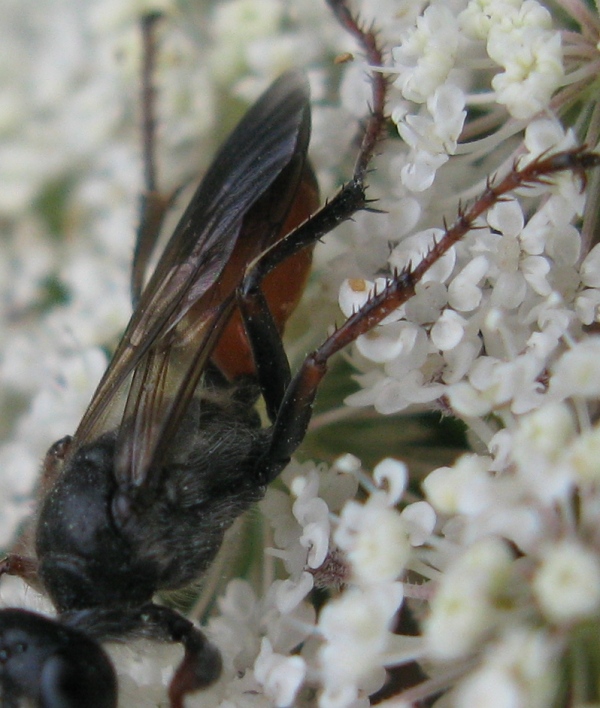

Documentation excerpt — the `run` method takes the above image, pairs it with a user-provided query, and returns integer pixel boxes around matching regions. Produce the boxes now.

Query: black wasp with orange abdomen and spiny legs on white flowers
[0,0,385,708]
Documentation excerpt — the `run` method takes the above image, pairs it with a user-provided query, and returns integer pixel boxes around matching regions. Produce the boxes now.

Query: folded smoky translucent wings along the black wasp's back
[73,72,310,487]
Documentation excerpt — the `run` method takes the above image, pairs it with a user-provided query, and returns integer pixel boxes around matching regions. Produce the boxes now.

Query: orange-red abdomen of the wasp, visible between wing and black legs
[212,168,319,380]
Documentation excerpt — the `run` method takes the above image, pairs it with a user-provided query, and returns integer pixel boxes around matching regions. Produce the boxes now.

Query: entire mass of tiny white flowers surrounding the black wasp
[0,0,600,708]
